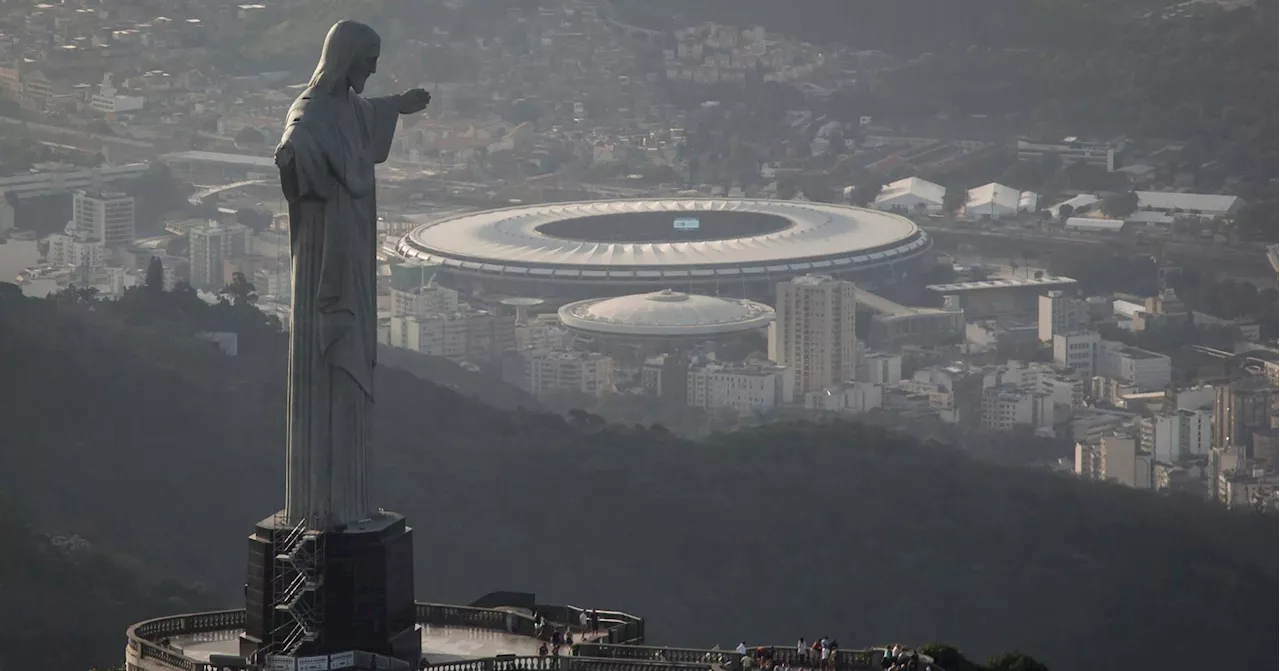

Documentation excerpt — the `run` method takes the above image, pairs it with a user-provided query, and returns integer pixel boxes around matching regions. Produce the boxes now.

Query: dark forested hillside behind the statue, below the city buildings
[0,288,1280,671]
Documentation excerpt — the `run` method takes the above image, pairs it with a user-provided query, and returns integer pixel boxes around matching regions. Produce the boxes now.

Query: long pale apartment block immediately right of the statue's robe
[388,310,516,364]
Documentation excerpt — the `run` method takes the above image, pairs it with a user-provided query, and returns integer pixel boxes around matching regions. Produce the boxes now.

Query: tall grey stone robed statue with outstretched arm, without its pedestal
[275,20,431,530]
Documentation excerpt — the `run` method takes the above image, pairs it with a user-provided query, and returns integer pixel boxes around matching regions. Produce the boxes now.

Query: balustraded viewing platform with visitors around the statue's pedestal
[125,593,884,671]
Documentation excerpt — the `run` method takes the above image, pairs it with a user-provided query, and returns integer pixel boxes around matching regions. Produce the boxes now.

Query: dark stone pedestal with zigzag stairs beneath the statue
[241,512,422,668]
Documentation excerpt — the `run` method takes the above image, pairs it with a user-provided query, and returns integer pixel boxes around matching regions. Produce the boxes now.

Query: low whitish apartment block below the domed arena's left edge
[503,350,613,396]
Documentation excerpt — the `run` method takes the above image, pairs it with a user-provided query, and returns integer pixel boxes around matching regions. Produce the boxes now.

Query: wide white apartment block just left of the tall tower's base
[686,361,795,414]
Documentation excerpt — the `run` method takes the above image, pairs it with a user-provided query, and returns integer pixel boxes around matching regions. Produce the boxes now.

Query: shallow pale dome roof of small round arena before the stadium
[559,289,773,337]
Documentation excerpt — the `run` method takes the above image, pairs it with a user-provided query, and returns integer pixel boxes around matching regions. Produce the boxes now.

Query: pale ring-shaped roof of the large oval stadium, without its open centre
[397,198,929,280]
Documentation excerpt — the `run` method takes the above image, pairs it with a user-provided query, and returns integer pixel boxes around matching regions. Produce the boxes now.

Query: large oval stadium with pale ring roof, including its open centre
[398,198,933,300]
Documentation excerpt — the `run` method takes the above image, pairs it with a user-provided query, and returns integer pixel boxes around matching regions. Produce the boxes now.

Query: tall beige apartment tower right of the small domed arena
[769,275,858,400]
